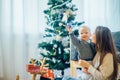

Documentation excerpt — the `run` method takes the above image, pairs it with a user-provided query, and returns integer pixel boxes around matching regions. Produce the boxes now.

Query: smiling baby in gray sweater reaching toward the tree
[66,26,95,61]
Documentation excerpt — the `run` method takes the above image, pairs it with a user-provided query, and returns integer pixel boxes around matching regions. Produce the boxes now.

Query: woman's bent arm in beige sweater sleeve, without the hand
[88,53,114,80]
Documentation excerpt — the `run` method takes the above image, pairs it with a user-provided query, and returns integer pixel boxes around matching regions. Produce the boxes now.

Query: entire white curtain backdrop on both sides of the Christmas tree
[0,0,120,80]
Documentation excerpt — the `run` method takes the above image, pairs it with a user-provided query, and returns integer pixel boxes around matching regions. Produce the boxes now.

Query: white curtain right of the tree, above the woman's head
[73,0,120,32]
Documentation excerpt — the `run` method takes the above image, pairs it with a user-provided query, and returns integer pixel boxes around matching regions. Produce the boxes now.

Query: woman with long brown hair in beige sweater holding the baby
[79,26,118,80]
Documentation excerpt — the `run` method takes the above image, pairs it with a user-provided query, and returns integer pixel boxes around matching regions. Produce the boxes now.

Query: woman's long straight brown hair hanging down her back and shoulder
[95,26,118,80]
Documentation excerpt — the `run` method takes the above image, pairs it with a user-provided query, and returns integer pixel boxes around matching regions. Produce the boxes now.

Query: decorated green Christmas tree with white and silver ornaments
[38,0,84,75]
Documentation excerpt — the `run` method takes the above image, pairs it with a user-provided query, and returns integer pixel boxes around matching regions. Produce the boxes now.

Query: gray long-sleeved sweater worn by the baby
[70,33,95,61]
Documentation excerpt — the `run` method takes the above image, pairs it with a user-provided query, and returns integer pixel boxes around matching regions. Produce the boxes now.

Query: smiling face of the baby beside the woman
[79,28,91,41]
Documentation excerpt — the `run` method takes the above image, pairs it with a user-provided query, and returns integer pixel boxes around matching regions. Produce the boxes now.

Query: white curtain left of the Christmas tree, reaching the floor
[0,0,47,80]
